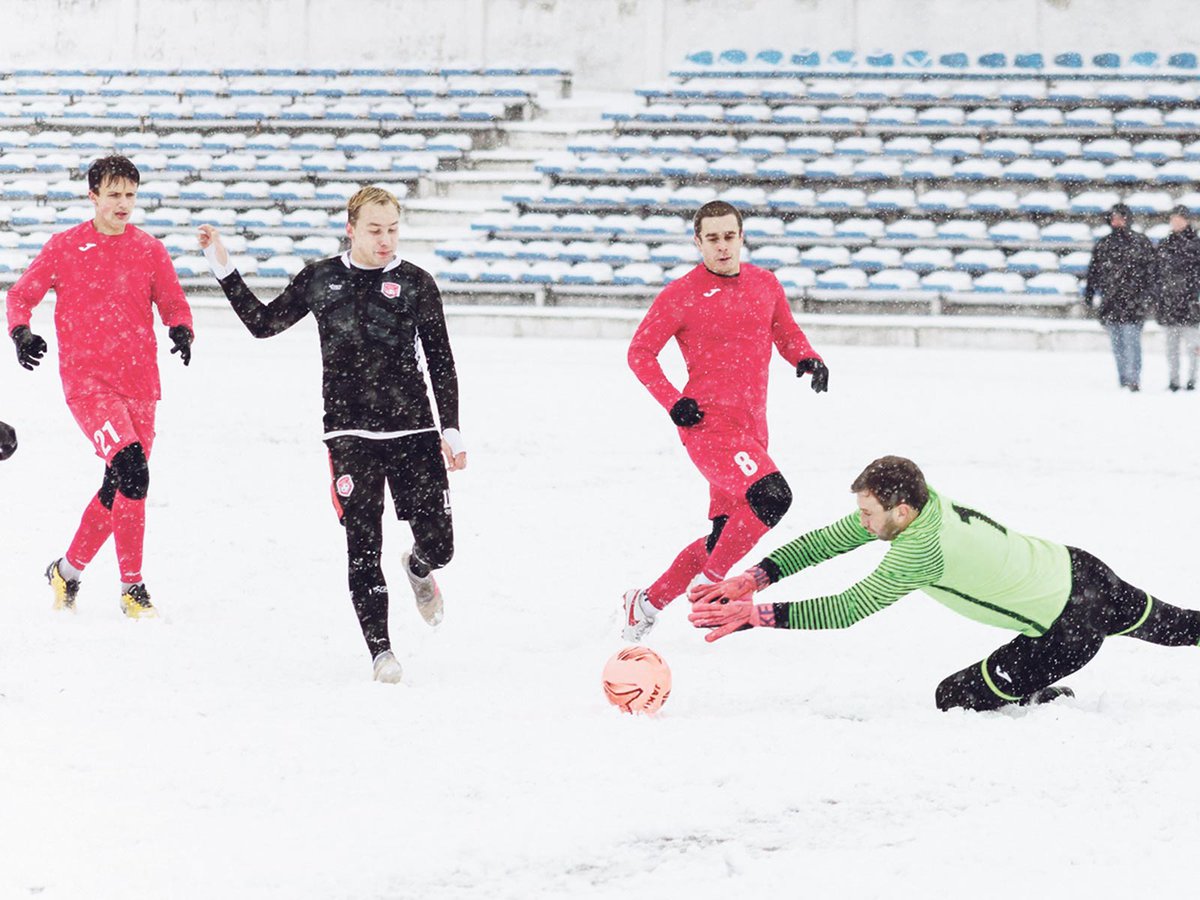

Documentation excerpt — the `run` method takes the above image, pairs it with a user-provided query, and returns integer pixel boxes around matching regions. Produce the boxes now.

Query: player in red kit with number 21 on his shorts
[7,156,193,618]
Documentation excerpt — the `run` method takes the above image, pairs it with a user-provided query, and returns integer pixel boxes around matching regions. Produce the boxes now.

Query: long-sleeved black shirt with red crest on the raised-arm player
[220,253,458,437]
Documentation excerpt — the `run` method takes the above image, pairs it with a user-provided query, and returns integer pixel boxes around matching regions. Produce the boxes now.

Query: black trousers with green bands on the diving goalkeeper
[935,547,1200,709]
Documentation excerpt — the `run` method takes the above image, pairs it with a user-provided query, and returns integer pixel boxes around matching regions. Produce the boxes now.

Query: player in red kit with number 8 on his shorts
[623,200,829,641]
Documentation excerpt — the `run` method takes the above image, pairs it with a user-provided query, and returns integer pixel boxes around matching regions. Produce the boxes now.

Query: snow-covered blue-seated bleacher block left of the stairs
[0,66,559,282]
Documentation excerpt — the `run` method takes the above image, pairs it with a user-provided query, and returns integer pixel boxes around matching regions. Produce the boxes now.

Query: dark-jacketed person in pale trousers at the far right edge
[1156,206,1200,391]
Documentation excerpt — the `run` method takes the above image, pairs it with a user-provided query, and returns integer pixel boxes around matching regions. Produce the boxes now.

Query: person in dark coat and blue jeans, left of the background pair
[1084,203,1158,391]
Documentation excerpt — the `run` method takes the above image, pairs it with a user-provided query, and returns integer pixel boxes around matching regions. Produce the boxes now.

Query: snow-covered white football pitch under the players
[0,311,1200,900]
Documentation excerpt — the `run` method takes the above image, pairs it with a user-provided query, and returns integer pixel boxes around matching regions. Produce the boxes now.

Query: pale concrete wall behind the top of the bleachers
[7,0,1200,90]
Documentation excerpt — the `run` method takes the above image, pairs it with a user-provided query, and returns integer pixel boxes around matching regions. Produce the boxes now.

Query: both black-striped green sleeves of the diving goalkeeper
[768,514,944,629]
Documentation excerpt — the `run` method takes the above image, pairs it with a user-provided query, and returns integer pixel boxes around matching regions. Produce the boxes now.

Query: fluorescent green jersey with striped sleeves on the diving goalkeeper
[763,488,1070,636]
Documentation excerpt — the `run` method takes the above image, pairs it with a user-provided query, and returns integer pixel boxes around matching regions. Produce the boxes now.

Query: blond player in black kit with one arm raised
[199,187,467,682]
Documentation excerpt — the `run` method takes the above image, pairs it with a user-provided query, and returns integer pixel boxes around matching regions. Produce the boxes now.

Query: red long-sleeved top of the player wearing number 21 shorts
[7,222,194,400]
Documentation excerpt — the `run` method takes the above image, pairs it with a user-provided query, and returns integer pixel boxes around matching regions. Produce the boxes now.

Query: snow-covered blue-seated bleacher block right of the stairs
[429,50,1200,312]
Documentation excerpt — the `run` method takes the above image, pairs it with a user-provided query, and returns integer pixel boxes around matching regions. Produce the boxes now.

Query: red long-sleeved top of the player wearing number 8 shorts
[629,263,820,443]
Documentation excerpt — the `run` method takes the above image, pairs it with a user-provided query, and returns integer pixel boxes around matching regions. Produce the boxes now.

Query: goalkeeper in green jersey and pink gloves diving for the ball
[689,456,1200,709]
